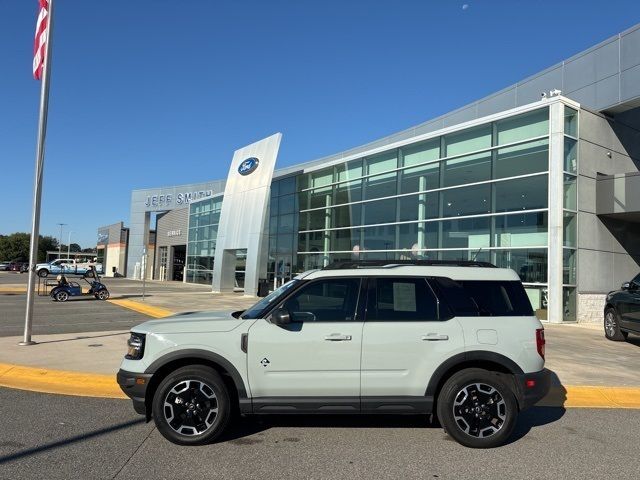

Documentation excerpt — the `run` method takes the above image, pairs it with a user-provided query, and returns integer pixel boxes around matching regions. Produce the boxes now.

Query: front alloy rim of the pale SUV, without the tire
[163,380,218,436]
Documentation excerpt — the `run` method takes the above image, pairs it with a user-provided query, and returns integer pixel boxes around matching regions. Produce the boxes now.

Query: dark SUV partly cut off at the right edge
[604,274,640,342]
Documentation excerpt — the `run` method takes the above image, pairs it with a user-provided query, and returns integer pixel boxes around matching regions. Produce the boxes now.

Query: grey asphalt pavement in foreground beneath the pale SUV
[0,388,640,480]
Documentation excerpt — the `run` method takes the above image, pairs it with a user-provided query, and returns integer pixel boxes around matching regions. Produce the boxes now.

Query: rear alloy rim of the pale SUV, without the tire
[453,383,507,438]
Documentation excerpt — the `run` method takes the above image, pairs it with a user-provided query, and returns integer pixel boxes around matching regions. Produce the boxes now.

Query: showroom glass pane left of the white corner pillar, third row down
[493,175,548,212]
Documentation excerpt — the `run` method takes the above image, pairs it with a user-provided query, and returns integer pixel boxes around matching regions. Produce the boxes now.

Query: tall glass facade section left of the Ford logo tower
[185,196,222,285]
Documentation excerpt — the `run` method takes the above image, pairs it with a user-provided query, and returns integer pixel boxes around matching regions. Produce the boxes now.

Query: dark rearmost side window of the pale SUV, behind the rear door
[430,278,533,317]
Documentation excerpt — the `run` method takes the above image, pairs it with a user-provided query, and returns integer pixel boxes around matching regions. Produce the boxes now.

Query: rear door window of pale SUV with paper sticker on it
[368,278,438,322]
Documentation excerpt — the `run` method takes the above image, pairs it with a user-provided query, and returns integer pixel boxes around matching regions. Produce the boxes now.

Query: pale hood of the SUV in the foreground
[131,311,244,334]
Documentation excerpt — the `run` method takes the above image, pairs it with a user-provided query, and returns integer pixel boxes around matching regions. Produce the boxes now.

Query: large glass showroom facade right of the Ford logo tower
[269,106,592,320]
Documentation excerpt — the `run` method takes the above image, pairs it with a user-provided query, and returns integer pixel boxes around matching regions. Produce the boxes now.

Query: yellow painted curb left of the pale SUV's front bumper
[0,363,127,398]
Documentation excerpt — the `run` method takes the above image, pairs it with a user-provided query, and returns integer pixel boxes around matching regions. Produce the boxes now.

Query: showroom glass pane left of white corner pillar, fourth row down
[493,212,548,247]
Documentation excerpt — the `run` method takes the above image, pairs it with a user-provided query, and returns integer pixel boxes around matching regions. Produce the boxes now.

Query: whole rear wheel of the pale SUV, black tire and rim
[436,368,518,448]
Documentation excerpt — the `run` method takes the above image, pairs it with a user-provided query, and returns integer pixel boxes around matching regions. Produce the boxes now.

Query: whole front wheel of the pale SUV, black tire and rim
[152,365,231,445]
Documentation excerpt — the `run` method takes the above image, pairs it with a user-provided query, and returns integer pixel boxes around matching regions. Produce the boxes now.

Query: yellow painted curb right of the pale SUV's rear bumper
[537,385,640,408]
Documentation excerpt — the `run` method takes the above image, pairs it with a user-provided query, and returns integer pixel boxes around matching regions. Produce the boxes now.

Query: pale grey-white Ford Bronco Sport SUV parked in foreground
[118,261,550,448]
